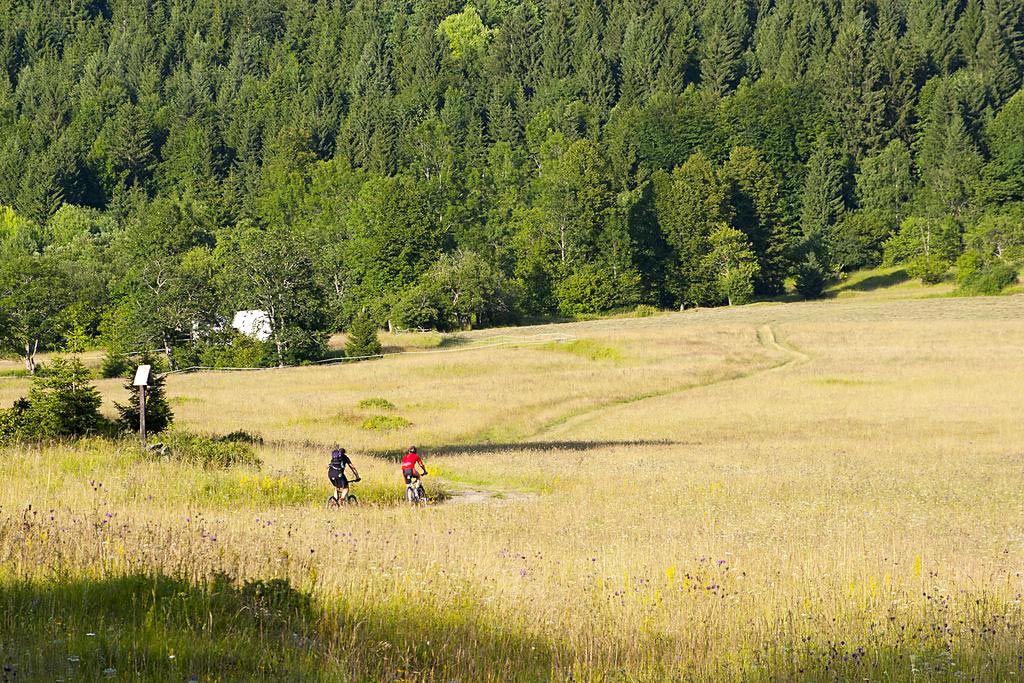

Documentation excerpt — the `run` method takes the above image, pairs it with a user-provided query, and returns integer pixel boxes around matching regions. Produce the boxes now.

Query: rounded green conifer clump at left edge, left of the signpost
[0,358,111,445]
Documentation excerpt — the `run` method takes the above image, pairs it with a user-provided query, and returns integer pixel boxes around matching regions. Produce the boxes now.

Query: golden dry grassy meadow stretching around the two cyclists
[0,292,1024,682]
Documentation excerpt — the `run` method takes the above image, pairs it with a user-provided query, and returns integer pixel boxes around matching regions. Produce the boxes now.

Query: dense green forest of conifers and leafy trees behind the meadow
[0,0,1024,365]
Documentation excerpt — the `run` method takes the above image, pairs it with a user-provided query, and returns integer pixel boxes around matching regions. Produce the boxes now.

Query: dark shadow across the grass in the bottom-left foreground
[0,574,554,681]
